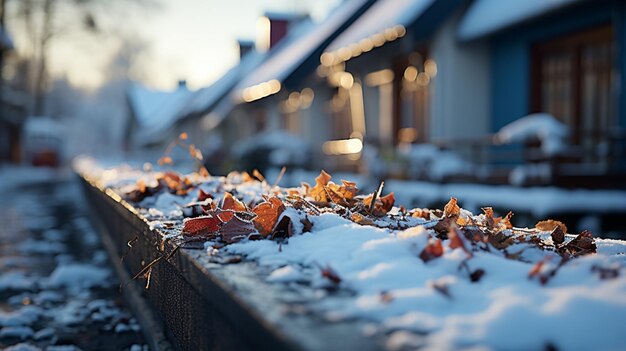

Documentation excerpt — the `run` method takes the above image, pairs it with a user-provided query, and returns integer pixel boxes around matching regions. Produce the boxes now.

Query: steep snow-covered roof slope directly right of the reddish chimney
[232,0,367,101]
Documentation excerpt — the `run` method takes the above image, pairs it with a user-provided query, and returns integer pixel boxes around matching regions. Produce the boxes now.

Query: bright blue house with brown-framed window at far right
[458,0,626,186]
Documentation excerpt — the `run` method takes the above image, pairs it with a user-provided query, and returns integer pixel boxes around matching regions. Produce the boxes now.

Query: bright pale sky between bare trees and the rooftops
[42,0,340,89]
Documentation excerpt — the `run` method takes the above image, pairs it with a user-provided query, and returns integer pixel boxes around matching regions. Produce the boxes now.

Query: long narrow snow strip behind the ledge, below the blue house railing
[385,179,626,218]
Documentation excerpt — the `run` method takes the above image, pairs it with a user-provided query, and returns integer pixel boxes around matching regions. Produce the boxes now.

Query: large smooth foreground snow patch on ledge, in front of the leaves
[226,215,626,349]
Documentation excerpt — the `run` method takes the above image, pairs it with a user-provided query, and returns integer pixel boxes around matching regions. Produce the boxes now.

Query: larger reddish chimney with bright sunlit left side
[257,12,308,52]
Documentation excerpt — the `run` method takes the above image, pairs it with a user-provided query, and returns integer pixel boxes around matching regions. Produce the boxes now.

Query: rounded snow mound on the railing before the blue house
[495,113,569,156]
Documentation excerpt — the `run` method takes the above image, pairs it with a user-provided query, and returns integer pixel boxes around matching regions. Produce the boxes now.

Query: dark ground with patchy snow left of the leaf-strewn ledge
[0,167,147,351]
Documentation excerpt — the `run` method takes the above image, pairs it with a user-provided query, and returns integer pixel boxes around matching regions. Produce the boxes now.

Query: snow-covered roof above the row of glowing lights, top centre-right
[327,0,434,52]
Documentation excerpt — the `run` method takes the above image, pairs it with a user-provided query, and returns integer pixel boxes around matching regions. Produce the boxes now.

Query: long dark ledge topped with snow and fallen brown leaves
[77,158,626,350]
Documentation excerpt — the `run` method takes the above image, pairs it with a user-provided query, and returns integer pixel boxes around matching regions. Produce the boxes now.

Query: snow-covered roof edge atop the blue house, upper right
[458,0,583,40]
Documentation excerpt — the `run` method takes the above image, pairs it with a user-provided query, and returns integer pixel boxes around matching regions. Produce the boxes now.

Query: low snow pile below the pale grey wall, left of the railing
[401,144,475,181]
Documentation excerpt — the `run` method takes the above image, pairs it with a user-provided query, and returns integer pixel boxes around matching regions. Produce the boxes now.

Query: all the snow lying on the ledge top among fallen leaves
[77,161,626,350]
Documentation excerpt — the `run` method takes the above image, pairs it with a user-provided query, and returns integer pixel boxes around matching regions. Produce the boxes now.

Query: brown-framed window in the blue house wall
[531,26,616,136]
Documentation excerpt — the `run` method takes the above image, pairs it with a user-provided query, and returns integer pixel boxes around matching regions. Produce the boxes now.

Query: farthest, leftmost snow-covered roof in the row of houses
[128,83,192,144]
